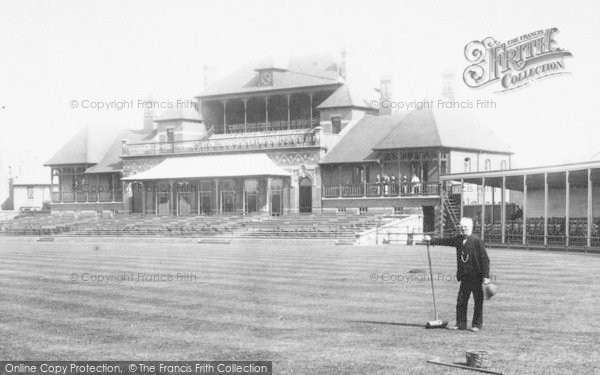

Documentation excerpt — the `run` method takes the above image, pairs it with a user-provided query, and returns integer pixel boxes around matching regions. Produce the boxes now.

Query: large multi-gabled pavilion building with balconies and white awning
[46,54,511,234]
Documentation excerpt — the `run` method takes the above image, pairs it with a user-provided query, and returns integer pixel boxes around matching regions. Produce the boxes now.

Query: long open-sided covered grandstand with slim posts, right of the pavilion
[441,161,600,250]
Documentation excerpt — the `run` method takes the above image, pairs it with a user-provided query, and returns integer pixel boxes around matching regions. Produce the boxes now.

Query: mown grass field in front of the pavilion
[0,238,600,374]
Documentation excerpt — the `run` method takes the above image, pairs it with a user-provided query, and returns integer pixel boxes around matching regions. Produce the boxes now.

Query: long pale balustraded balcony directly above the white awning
[123,131,320,156]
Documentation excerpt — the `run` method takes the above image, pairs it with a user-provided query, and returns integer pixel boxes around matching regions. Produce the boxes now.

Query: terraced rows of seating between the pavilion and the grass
[0,214,392,239]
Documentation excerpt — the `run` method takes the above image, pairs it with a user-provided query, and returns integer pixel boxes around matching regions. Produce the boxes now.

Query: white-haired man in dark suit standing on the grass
[425,217,490,332]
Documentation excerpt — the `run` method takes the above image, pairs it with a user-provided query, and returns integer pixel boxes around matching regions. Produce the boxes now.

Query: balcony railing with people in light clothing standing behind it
[323,182,440,198]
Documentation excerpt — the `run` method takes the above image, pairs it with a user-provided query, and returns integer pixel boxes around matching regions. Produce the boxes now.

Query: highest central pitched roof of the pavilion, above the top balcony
[199,54,341,97]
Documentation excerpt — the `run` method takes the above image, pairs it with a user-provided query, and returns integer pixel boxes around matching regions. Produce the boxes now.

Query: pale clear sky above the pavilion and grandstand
[0,0,600,191]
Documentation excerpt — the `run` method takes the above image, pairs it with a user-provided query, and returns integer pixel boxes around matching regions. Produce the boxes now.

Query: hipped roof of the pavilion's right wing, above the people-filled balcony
[373,109,511,153]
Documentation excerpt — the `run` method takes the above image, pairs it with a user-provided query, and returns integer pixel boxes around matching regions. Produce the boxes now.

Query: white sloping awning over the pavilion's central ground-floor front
[123,154,291,181]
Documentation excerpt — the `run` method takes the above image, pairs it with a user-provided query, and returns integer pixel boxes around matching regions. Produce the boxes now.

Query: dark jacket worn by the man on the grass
[431,235,490,282]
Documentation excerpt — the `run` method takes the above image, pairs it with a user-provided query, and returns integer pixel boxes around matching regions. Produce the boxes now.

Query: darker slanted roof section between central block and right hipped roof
[321,113,405,164]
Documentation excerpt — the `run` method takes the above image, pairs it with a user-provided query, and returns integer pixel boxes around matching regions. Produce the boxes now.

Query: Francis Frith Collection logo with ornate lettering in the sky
[463,27,572,92]
